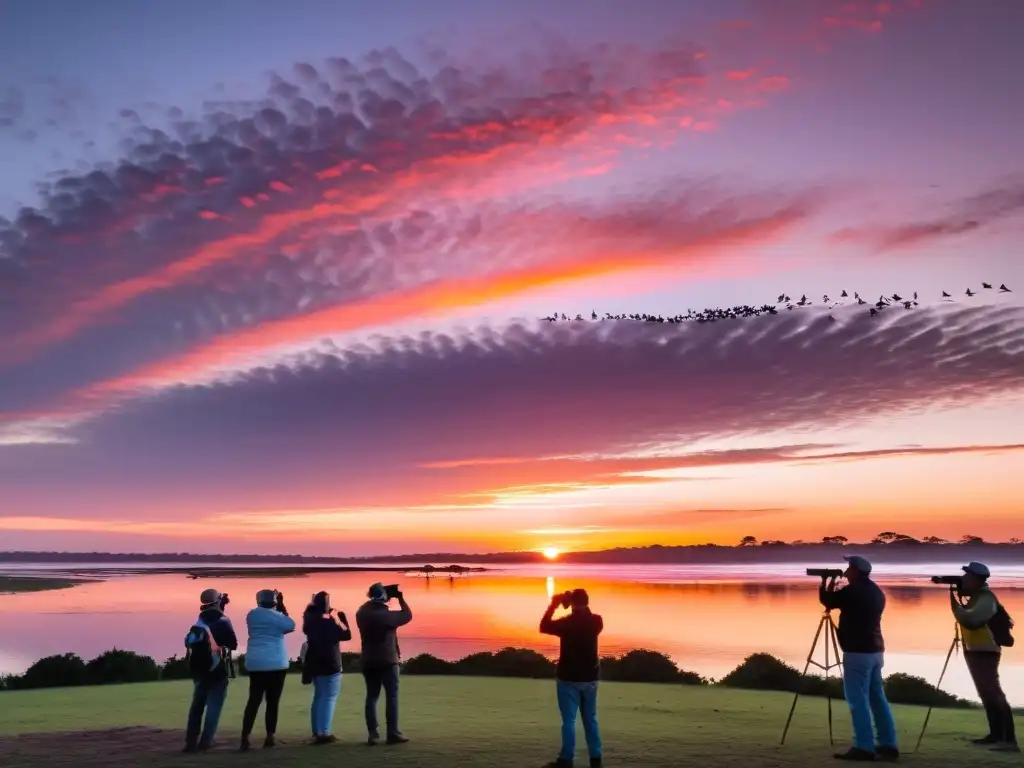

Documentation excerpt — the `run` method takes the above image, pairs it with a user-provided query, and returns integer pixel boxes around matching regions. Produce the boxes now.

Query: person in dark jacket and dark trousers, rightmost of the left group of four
[355,582,413,746]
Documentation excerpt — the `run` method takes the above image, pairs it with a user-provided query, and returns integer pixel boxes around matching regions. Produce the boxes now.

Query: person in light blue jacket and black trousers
[241,590,295,752]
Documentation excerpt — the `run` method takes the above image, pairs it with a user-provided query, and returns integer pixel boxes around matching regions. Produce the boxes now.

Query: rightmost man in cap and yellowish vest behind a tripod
[949,562,1020,752]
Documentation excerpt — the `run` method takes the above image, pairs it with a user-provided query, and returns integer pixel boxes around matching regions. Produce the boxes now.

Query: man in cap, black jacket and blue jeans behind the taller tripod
[818,555,899,762]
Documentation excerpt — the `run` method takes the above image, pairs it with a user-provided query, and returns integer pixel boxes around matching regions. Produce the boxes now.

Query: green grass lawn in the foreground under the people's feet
[0,675,1024,768]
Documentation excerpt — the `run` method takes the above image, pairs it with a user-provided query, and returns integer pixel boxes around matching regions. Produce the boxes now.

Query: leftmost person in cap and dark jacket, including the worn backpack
[184,589,239,752]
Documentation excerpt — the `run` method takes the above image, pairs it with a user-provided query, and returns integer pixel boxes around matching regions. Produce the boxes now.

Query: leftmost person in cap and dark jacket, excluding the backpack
[184,589,239,752]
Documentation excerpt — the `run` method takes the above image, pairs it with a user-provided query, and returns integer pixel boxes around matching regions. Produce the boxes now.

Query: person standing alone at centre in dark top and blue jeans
[541,589,604,768]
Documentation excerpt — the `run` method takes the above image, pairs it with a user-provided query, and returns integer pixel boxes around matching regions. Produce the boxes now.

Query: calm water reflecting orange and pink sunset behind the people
[0,563,1024,706]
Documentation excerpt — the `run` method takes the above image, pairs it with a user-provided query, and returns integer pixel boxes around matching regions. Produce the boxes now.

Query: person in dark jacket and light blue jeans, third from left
[302,592,352,744]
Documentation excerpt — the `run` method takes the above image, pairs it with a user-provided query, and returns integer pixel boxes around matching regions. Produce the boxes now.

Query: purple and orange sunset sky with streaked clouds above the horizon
[0,0,1024,555]
